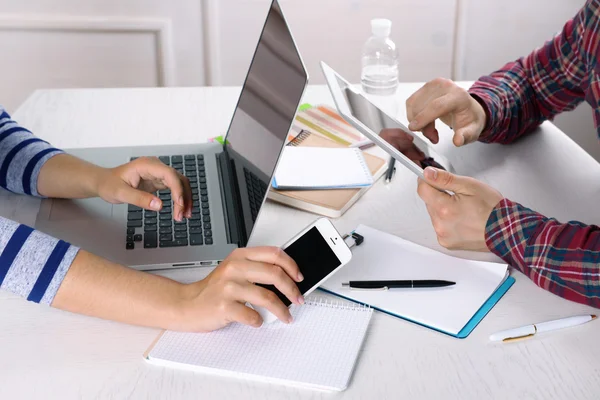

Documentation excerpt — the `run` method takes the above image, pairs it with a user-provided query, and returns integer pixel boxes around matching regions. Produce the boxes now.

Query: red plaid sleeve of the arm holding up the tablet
[485,199,600,308]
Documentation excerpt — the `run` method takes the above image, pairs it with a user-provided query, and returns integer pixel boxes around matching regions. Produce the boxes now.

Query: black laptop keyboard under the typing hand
[125,154,213,250]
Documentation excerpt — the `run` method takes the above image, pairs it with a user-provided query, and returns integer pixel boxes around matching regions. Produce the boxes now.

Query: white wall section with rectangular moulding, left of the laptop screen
[0,0,206,110]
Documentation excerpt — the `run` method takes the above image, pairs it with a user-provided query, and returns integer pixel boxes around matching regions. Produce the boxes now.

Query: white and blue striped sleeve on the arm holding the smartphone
[0,217,79,305]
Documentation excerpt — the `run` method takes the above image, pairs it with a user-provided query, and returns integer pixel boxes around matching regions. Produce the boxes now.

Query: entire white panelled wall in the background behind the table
[0,0,600,160]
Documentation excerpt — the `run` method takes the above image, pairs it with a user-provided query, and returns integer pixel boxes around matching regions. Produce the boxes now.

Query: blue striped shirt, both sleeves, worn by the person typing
[0,106,79,305]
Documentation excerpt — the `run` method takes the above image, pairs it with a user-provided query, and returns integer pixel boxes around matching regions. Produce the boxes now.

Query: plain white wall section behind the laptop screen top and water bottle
[208,0,456,85]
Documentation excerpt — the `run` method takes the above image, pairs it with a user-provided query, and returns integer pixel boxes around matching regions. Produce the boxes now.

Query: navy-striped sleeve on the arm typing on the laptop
[0,106,62,197]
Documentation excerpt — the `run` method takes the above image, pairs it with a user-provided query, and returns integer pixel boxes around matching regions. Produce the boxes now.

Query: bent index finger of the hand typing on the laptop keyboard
[136,158,185,221]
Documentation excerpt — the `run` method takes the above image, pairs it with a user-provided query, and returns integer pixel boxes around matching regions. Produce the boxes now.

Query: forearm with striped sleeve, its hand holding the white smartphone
[0,217,191,329]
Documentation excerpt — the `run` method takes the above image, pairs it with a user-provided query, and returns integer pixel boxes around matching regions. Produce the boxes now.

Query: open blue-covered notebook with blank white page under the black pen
[321,225,515,339]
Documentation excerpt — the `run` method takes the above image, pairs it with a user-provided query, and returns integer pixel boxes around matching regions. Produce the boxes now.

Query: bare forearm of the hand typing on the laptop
[37,154,106,199]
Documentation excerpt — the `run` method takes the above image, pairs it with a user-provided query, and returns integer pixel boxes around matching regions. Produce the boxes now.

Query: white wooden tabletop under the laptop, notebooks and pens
[0,84,600,399]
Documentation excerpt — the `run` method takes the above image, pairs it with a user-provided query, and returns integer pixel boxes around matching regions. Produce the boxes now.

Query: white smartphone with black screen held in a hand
[252,218,352,323]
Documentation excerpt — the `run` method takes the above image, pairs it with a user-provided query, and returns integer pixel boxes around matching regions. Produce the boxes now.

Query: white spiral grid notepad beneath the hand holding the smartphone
[146,298,372,390]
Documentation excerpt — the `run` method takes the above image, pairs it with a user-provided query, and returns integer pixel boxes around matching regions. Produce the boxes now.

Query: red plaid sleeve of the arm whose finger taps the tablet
[469,0,588,144]
